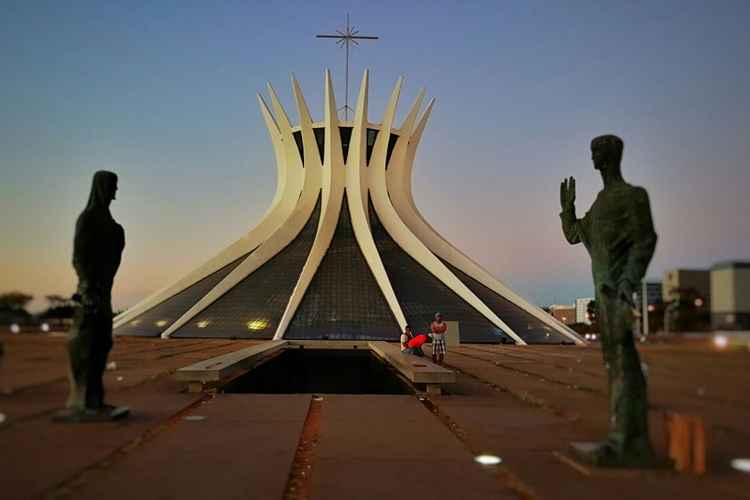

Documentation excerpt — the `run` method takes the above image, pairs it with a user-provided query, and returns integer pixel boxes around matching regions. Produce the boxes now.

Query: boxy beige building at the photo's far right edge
[711,261,750,330]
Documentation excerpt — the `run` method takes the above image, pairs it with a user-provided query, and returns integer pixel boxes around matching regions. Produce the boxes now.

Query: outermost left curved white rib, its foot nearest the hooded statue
[114,94,302,328]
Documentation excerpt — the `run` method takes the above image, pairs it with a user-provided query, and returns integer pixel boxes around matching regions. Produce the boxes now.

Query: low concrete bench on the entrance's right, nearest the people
[369,342,456,395]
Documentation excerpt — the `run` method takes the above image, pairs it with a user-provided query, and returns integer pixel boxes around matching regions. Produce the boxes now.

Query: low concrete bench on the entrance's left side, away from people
[175,340,288,392]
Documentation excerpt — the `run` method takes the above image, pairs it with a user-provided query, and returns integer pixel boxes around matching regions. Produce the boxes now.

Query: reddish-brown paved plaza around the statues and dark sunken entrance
[0,334,750,500]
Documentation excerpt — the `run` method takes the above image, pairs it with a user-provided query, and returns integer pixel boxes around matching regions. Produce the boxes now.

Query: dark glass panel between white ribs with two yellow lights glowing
[172,199,320,339]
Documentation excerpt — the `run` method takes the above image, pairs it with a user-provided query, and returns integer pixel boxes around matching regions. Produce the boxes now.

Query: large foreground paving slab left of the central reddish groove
[70,394,310,500]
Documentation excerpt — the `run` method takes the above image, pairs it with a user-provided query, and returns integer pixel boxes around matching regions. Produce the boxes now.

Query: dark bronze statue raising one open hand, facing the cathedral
[560,135,656,466]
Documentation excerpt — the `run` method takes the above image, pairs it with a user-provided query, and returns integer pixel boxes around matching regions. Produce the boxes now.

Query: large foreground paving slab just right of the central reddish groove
[312,395,515,500]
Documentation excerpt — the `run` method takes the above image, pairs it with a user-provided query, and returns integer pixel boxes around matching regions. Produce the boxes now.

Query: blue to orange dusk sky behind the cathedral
[0,0,750,308]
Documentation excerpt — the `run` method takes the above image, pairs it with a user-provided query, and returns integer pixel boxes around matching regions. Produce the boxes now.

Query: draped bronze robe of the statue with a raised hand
[560,181,656,456]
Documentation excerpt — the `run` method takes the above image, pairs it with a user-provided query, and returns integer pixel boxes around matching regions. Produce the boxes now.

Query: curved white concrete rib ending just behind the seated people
[346,70,406,330]
